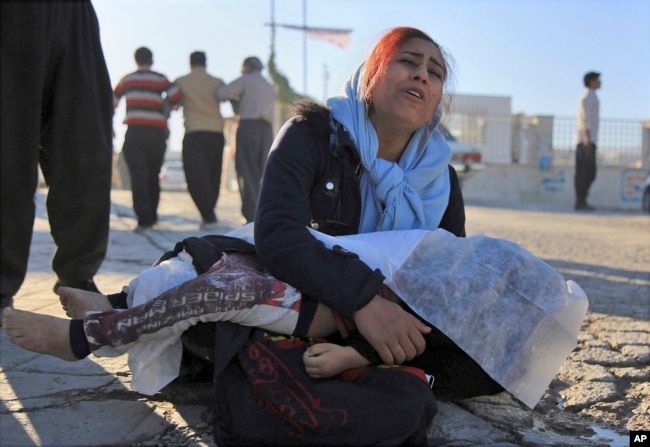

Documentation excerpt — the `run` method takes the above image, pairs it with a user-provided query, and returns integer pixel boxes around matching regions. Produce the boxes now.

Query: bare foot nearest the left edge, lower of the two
[2,307,79,362]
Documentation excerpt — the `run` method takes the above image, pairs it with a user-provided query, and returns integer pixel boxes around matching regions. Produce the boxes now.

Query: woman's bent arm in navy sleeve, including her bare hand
[255,109,430,363]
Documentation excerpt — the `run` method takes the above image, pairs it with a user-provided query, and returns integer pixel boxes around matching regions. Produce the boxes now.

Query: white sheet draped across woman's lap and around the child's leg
[95,223,588,408]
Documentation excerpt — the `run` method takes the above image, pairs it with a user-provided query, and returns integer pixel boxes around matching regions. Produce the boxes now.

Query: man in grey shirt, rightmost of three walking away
[218,56,276,222]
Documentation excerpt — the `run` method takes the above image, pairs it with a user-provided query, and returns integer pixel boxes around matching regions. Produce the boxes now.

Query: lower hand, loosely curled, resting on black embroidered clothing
[302,343,368,379]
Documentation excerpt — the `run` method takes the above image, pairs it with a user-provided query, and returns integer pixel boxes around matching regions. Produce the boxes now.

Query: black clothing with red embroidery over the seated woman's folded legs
[214,323,437,446]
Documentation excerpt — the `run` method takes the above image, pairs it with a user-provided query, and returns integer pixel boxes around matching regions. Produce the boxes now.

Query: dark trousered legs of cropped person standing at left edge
[0,1,113,316]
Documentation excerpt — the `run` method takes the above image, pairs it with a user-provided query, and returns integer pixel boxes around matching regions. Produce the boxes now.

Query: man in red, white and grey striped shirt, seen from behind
[114,47,181,233]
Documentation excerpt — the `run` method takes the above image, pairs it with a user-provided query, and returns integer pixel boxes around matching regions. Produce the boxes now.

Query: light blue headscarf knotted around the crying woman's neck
[327,64,451,233]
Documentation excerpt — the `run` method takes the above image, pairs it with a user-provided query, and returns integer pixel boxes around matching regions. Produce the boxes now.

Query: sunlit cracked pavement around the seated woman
[0,186,650,447]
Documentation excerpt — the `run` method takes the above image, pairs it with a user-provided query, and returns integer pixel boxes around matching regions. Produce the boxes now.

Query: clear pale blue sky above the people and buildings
[93,0,650,151]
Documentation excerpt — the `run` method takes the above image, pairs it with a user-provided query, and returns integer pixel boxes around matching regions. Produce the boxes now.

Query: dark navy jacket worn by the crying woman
[255,101,465,335]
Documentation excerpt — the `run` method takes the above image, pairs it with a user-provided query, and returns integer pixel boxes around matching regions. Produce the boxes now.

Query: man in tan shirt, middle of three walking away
[174,51,225,231]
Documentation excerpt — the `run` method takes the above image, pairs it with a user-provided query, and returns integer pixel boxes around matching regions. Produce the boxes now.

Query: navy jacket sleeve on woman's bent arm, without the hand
[255,119,384,319]
